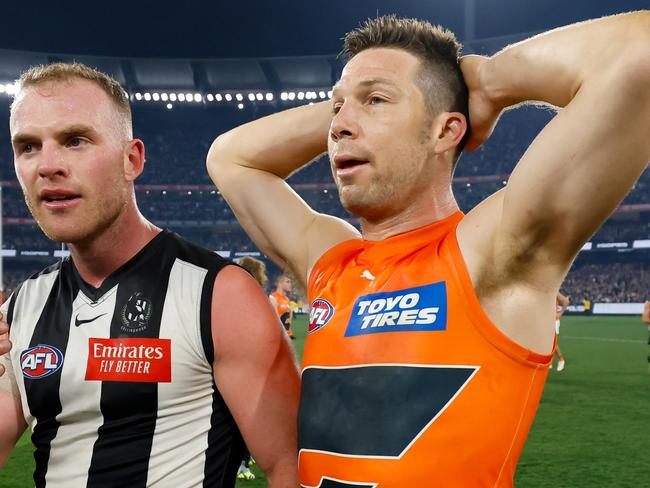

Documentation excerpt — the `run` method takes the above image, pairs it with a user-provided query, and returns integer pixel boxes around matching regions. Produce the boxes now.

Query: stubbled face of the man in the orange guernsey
[328,48,432,219]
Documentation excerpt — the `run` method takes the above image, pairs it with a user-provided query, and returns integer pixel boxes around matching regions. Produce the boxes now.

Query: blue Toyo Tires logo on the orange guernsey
[345,281,447,337]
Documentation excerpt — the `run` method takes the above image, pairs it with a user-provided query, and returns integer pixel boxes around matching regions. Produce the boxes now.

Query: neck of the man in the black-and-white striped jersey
[69,208,160,288]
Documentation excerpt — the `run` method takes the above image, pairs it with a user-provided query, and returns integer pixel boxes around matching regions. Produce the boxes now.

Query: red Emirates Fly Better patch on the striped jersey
[86,337,172,383]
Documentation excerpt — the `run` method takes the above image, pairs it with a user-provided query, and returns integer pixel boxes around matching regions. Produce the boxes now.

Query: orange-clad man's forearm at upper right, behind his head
[480,11,650,108]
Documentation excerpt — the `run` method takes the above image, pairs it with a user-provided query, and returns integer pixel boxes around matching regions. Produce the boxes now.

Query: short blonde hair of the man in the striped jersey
[12,63,133,139]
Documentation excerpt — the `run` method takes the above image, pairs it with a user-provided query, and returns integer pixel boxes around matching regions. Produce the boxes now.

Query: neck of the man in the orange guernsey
[361,189,460,241]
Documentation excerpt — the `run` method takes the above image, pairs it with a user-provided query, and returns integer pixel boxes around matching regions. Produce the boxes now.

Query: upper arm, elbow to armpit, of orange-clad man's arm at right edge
[500,74,650,265]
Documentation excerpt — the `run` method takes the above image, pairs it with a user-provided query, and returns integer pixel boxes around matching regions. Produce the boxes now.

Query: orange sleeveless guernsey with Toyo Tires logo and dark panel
[298,212,552,488]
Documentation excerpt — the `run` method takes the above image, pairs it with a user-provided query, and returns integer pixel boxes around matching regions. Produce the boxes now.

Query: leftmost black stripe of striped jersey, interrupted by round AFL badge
[22,261,79,488]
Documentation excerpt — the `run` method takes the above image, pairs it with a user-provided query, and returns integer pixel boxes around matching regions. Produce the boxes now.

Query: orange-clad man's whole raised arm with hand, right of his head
[459,12,650,295]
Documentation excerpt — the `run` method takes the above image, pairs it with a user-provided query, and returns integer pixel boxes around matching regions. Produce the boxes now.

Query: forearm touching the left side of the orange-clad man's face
[208,101,332,178]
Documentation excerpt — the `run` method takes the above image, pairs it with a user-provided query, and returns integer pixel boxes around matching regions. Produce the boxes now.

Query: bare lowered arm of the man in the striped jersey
[212,266,300,488]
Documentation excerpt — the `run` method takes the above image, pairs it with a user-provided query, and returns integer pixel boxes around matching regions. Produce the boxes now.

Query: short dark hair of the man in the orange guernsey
[341,15,469,159]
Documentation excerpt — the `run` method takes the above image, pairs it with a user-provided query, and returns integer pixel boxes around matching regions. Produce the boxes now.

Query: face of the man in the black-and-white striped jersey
[10,79,130,248]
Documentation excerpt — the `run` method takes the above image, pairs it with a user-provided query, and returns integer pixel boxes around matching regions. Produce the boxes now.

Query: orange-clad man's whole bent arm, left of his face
[207,102,358,284]
